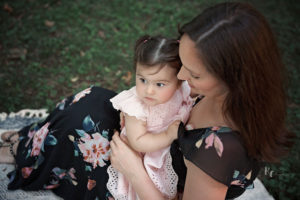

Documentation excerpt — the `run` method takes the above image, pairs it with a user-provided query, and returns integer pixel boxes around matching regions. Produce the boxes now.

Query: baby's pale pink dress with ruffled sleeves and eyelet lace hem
[107,82,193,200]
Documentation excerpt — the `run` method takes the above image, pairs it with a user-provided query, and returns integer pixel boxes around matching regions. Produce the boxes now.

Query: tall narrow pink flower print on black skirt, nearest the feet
[30,122,50,156]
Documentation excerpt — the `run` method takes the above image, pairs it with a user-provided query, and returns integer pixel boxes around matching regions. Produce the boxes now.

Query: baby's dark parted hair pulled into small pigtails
[134,35,181,72]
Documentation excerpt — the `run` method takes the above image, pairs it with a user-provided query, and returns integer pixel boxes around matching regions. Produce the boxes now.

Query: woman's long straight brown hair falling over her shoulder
[179,3,292,162]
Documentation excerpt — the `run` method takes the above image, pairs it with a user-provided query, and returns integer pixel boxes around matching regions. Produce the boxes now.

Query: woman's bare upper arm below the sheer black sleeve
[183,160,228,200]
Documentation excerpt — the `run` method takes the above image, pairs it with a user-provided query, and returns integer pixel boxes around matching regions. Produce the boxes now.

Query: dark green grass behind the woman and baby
[0,0,300,199]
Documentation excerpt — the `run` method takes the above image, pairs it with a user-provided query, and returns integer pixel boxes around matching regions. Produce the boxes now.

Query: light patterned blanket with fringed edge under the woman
[0,109,274,200]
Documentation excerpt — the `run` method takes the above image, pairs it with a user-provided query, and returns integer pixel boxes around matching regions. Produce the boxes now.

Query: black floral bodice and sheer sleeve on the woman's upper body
[171,123,262,199]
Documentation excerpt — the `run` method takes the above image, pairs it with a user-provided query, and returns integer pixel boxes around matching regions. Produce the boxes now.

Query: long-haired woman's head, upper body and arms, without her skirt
[111,3,292,200]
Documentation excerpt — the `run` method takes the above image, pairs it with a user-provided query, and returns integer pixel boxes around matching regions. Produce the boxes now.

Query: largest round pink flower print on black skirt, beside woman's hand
[78,133,110,169]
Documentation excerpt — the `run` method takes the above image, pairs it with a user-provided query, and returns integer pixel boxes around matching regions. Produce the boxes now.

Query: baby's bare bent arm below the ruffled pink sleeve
[125,114,180,152]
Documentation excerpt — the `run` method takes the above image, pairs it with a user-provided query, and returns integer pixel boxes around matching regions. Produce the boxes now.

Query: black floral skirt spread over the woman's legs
[8,87,120,200]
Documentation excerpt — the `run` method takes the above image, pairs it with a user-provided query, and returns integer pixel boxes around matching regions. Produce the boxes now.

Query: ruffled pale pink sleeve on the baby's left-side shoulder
[110,87,148,121]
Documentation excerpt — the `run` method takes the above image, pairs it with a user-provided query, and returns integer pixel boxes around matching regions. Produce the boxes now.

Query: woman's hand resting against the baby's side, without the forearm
[110,132,144,177]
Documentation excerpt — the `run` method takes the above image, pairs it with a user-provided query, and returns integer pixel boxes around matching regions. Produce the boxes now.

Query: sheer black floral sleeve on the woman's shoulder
[178,123,257,188]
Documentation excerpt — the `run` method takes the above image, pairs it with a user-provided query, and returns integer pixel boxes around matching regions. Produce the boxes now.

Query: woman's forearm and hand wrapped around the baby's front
[110,132,165,200]
